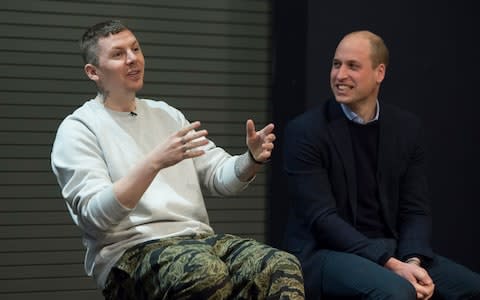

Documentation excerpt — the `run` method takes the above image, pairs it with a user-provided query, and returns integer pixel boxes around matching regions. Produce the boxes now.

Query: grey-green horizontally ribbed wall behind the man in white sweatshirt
[0,0,270,300]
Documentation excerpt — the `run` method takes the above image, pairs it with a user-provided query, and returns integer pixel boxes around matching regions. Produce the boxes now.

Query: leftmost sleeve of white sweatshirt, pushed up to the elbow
[51,117,131,236]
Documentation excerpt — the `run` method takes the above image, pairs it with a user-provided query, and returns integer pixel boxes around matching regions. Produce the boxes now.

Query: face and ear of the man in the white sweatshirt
[84,30,145,99]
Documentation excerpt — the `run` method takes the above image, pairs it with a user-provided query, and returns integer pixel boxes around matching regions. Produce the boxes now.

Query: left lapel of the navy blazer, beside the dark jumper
[327,101,357,223]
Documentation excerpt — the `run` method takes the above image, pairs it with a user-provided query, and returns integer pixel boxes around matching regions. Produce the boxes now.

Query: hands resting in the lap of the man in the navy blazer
[385,257,435,300]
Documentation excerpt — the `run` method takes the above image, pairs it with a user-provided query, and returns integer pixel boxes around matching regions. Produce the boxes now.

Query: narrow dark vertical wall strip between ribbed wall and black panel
[267,0,308,247]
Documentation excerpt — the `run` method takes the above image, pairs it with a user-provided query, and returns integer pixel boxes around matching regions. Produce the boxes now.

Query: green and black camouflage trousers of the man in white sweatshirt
[103,234,304,300]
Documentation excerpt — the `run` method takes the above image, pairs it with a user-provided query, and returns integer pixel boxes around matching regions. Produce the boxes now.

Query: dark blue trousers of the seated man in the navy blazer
[303,250,480,300]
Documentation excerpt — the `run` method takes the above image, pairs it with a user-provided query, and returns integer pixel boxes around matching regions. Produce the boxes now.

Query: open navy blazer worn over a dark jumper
[284,99,433,263]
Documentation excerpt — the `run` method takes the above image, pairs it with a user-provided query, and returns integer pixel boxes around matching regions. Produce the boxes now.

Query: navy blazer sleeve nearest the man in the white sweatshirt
[284,120,392,265]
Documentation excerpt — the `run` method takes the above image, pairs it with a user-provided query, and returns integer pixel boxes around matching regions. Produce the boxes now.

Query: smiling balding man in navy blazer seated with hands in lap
[284,31,480,299]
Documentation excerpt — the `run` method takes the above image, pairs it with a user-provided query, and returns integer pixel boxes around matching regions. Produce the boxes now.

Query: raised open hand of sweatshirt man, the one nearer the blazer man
[246,120,275,162]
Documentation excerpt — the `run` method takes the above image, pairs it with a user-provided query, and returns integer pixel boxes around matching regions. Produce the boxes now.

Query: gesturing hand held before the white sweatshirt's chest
[154,121,208,168]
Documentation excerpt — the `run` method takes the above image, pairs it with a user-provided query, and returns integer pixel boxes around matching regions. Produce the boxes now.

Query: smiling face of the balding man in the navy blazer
[330,33,386,111]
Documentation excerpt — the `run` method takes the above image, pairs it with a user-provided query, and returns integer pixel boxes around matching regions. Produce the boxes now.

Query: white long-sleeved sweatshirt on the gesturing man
[51,96,248,288]
